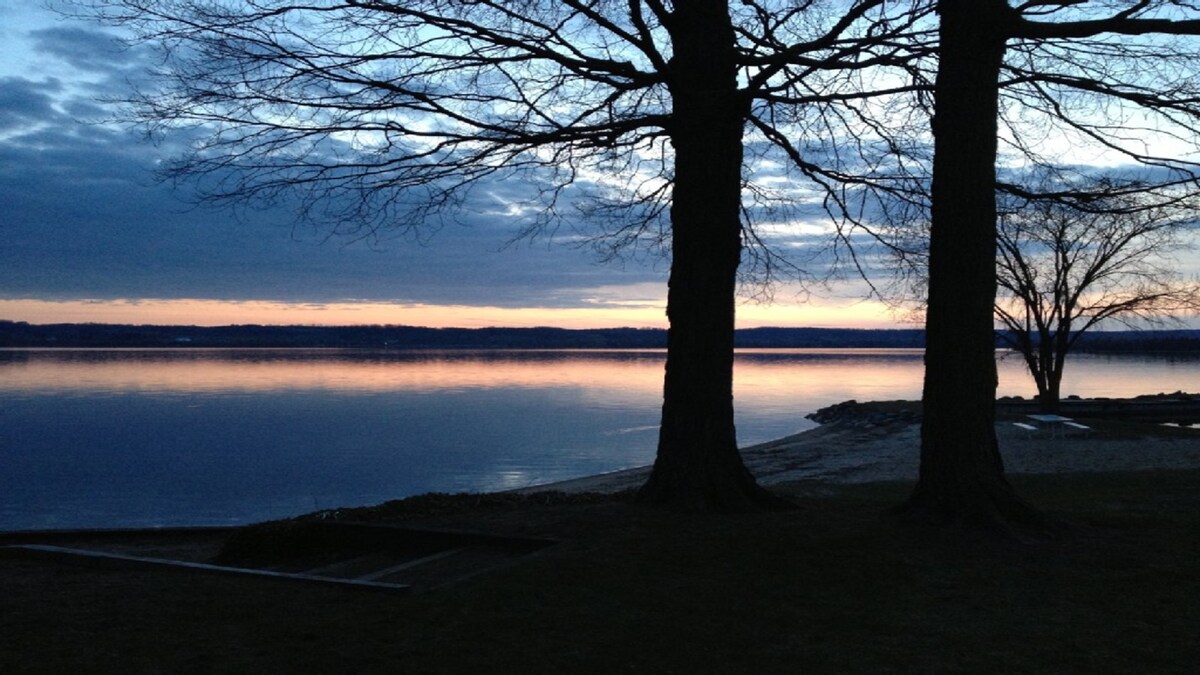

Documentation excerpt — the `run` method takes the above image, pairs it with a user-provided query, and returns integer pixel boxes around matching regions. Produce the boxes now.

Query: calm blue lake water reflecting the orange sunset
[0,350,1200,530]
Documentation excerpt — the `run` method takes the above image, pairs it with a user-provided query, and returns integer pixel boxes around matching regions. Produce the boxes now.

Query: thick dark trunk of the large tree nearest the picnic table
[900,0,1036,527]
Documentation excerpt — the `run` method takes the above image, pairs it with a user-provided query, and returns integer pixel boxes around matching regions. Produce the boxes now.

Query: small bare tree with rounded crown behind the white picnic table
[996,186,1200,413]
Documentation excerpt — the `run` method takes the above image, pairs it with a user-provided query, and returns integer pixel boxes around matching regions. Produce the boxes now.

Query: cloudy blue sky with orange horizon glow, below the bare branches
[0,0,916,328]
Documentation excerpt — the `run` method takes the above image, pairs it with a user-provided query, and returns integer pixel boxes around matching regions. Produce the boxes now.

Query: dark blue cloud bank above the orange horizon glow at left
[0,80,662,306]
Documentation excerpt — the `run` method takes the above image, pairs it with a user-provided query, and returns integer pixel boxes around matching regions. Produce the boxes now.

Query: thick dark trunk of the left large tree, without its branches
[638,0,778,510]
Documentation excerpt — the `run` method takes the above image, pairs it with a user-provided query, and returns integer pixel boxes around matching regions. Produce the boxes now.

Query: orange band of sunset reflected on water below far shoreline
[0,350,920,393]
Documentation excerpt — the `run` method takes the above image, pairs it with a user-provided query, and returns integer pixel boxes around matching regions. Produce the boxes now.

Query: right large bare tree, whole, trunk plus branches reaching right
[900,0,1200,530]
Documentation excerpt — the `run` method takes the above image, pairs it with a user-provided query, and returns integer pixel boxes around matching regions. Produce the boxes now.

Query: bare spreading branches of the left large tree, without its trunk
[67,0,934,274]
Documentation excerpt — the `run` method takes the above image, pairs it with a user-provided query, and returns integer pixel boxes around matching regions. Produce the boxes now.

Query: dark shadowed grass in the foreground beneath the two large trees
[0,471,1200,673]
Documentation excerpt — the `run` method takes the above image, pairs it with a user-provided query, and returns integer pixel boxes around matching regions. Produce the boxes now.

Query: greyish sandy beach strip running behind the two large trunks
[522,413,1200,492]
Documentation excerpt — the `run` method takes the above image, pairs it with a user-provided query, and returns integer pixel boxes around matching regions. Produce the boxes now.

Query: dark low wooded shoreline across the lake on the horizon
[0,321,1200,352]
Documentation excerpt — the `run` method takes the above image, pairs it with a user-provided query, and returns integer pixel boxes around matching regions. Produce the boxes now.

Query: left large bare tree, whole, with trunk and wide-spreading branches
[66,0,930,509]
